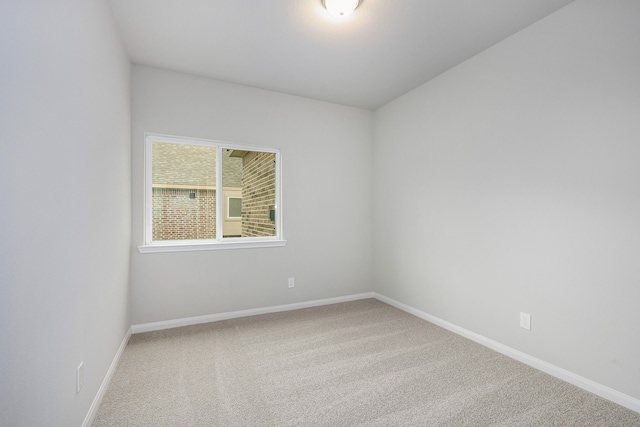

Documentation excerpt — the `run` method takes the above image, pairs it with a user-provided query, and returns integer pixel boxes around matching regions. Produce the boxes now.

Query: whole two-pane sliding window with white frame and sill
[138,135,286,253]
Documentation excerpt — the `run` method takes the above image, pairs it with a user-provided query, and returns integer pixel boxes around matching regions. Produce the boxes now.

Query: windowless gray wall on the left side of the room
[0,0,131,427]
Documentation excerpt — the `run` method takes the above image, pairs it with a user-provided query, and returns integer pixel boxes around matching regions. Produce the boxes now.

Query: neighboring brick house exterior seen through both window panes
[152,142,275,241]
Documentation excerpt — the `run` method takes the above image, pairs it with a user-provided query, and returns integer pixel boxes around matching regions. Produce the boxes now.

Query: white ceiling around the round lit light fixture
[110,0,573,109]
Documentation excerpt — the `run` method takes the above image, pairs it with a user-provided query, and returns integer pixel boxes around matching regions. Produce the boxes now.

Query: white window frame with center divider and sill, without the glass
[138,133,287,253]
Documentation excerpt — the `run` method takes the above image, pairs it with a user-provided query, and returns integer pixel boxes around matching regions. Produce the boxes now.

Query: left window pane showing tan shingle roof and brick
[151,142,216,241]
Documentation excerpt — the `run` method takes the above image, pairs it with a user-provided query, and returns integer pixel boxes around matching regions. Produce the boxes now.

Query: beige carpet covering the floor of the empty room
[93,299,640,427]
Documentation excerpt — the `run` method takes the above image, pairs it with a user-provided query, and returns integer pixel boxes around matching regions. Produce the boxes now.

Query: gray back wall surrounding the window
[131,66,373,324]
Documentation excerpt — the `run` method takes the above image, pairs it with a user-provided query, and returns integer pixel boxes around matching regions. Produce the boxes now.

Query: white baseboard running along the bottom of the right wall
[373,292,640,412]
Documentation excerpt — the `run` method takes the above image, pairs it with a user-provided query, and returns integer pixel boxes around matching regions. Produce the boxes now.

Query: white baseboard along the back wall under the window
[131,292,374,334]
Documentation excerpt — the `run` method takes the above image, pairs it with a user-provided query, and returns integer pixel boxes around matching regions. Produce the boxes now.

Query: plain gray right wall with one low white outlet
[374,0,640,398]
